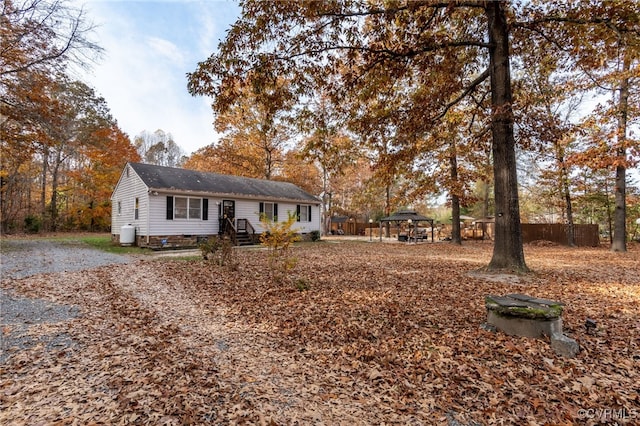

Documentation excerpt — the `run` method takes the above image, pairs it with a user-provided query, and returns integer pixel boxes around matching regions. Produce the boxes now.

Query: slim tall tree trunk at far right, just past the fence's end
[611,54,631,252]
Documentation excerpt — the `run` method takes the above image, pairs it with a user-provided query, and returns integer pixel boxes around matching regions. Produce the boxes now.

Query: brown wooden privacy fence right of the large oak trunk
[522,223,600,247]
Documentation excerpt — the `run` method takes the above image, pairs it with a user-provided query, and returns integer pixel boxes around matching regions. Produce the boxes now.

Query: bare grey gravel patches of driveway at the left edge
[0,239,131,363]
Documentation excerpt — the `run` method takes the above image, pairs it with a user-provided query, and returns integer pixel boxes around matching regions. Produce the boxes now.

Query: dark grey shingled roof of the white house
[129,163,319,203]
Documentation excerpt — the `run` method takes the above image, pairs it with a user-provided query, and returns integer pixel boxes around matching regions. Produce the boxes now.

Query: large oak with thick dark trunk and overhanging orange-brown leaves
[189,0,636,271]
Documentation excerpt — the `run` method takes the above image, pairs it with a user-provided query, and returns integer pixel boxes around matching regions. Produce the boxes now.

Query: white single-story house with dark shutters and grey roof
[111,163,321,248]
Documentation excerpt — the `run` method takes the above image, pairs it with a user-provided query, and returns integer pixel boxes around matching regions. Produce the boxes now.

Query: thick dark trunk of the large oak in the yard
[486,1,528,271]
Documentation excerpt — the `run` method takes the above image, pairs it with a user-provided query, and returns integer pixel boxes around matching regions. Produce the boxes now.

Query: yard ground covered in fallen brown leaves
[0,242,640,425]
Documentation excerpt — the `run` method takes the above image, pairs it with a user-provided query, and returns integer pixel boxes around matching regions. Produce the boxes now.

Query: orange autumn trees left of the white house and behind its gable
[0,0,184,233]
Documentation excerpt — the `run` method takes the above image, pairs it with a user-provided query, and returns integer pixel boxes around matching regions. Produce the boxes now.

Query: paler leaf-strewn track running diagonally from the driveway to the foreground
[104,264,404,425]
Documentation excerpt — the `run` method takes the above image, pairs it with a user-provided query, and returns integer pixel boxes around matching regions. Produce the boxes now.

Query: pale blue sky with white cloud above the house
[77,0,240,155]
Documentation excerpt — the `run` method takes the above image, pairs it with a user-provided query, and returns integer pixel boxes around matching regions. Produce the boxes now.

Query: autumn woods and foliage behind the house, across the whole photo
[0,0,640,248]
